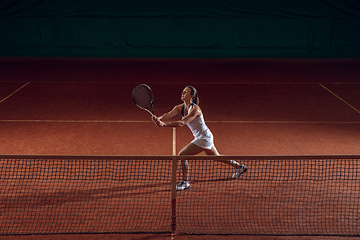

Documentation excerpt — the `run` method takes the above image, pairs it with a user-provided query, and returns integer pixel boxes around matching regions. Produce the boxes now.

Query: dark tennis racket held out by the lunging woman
[133,84,155,117]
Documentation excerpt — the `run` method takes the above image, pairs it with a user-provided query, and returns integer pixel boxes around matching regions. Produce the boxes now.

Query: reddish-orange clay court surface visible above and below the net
[0,58,360,240]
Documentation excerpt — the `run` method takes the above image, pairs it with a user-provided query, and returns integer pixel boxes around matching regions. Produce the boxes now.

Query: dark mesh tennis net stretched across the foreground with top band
[0,155,360,236]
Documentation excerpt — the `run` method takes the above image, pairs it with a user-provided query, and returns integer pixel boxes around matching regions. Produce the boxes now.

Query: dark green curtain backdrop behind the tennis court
[0,0,360,57]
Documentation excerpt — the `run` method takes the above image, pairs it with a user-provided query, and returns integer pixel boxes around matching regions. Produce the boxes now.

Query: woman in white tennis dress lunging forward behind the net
[152,86,248,190]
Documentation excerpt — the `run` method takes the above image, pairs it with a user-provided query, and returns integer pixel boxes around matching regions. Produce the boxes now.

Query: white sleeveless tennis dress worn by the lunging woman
[181,104,214,149]
